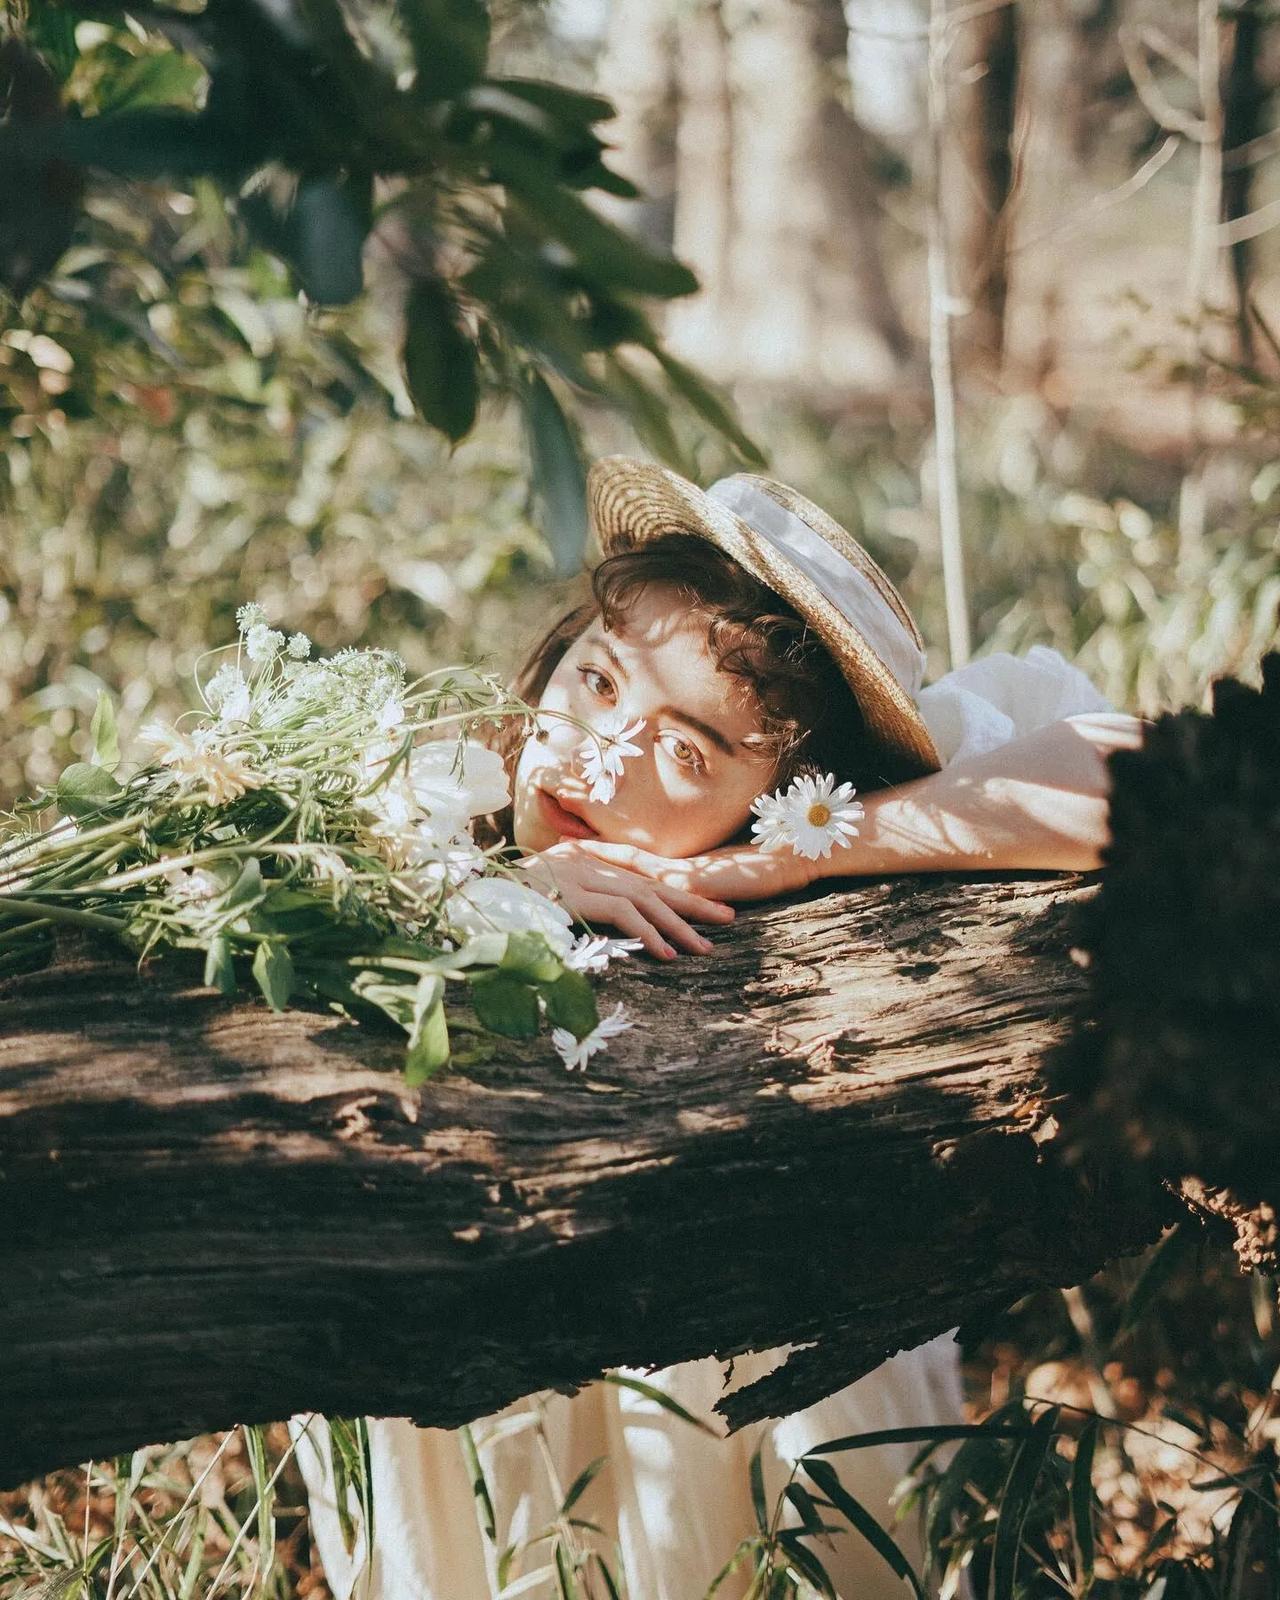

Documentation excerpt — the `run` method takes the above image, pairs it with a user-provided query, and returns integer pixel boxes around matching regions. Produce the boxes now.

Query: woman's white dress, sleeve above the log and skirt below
[293,646,1110,1600]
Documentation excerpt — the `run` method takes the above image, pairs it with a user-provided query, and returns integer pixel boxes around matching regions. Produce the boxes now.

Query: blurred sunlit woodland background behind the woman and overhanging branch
[0,0,1280,802]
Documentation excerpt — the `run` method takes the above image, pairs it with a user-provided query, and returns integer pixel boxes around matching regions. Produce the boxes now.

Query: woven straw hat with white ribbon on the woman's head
[587,456,942,781]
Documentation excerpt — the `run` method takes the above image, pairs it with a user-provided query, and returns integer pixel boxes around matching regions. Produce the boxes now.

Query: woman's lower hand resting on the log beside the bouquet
[520,838,733,962]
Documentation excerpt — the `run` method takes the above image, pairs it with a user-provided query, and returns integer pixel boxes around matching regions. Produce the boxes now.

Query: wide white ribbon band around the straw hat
[707,477,925,698]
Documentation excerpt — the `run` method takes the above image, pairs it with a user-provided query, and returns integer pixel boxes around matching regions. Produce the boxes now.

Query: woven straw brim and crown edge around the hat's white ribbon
[587,456,942,782]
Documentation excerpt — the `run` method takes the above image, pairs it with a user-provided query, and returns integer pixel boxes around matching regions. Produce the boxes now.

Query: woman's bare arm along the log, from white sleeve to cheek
[579,712,1142,901]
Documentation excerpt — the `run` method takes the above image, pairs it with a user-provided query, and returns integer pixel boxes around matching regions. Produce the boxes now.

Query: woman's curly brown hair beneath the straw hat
[493,533,909,838]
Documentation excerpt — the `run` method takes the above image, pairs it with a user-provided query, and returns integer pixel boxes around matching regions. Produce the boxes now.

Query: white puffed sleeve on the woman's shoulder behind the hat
[917,645,1115,766]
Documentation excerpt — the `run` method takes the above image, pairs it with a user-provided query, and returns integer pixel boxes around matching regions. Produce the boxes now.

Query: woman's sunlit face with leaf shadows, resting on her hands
[514,584,771,856]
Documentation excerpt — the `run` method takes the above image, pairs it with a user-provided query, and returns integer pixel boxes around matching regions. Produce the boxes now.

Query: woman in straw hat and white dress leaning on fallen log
[299,458,1138,1600]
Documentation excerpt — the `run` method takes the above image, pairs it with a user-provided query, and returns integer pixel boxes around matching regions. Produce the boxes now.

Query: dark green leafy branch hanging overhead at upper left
[0,0,760,473]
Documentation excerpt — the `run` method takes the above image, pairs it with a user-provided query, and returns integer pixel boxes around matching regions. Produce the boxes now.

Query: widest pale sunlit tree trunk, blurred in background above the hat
[640,0,909,392]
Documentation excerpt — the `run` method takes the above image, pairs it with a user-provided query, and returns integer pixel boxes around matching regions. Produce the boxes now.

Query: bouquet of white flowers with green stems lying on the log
[0,605,627,1083]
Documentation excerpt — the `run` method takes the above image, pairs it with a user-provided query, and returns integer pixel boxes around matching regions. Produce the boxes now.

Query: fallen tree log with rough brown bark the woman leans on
[0,878,1165,1485]
